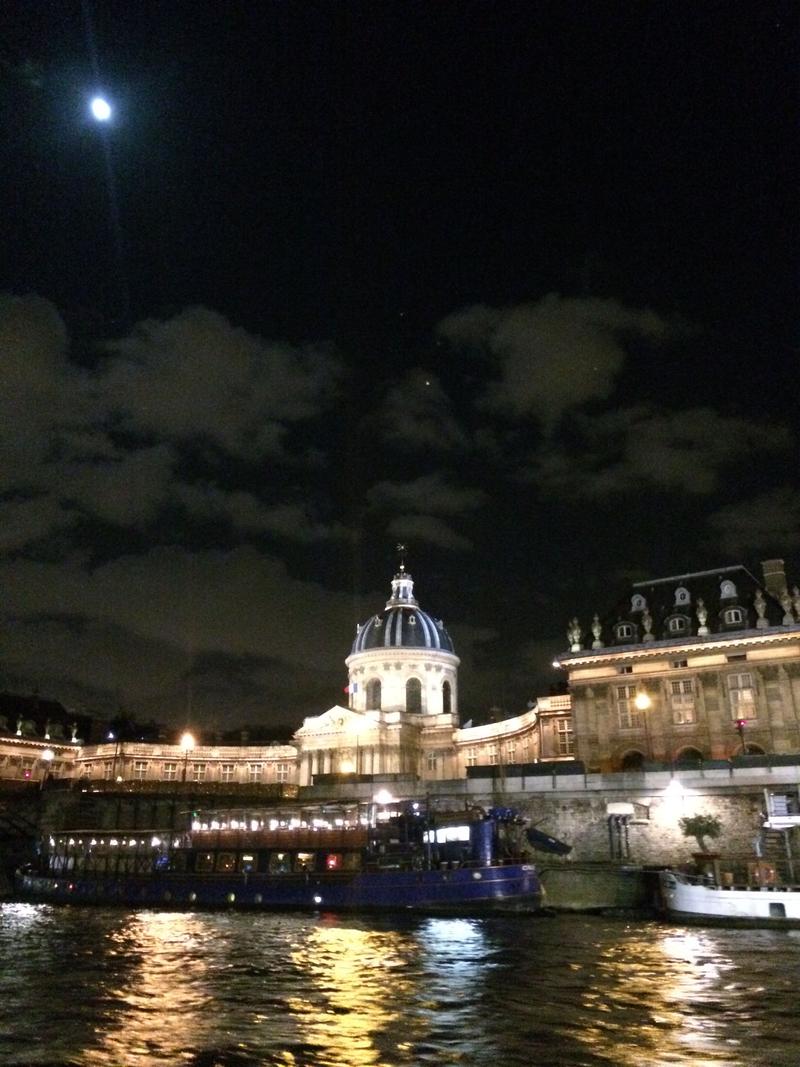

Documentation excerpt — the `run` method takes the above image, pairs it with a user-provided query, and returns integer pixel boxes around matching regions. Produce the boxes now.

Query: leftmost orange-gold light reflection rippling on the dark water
[81,911,214,1067]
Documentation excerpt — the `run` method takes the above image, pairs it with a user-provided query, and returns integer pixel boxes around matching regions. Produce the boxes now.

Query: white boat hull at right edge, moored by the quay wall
[659,871,800,926]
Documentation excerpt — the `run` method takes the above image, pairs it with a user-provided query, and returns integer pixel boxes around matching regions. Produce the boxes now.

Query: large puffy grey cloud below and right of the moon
[98,307,340,459]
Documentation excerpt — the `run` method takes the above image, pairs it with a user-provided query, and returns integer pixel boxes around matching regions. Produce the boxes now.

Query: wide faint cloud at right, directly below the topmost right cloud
[527,407,791,498]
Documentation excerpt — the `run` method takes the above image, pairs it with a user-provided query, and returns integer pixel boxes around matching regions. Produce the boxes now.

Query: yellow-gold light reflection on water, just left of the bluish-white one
[287,919,417,1067]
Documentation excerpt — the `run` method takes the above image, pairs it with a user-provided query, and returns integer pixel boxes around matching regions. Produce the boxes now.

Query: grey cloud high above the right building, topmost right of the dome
[437,293,669,431]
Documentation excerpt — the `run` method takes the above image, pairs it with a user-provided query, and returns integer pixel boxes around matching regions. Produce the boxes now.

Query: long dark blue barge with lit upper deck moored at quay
[15,800,541,914]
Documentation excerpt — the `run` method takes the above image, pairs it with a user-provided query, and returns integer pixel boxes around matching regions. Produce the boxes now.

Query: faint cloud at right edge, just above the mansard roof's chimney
[708,485,800,557]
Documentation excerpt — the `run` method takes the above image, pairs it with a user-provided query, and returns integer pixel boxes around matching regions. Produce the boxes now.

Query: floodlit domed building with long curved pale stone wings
[0,561,574,787]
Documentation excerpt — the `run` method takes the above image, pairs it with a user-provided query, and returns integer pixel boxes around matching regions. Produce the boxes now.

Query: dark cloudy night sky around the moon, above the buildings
[0,0,800,728]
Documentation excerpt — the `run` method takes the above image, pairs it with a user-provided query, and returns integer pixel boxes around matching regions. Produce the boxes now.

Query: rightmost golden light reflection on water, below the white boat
[570,929,737,1067]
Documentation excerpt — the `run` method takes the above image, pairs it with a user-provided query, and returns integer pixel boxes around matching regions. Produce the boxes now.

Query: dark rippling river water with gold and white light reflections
[0,904,800,1067]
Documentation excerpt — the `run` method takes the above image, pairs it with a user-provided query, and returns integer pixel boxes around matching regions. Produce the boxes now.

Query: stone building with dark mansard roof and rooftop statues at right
[559,559,800,771]
